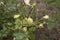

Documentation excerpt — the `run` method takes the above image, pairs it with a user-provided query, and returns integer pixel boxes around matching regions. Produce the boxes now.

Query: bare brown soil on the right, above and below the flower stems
[32,0,60,40]
